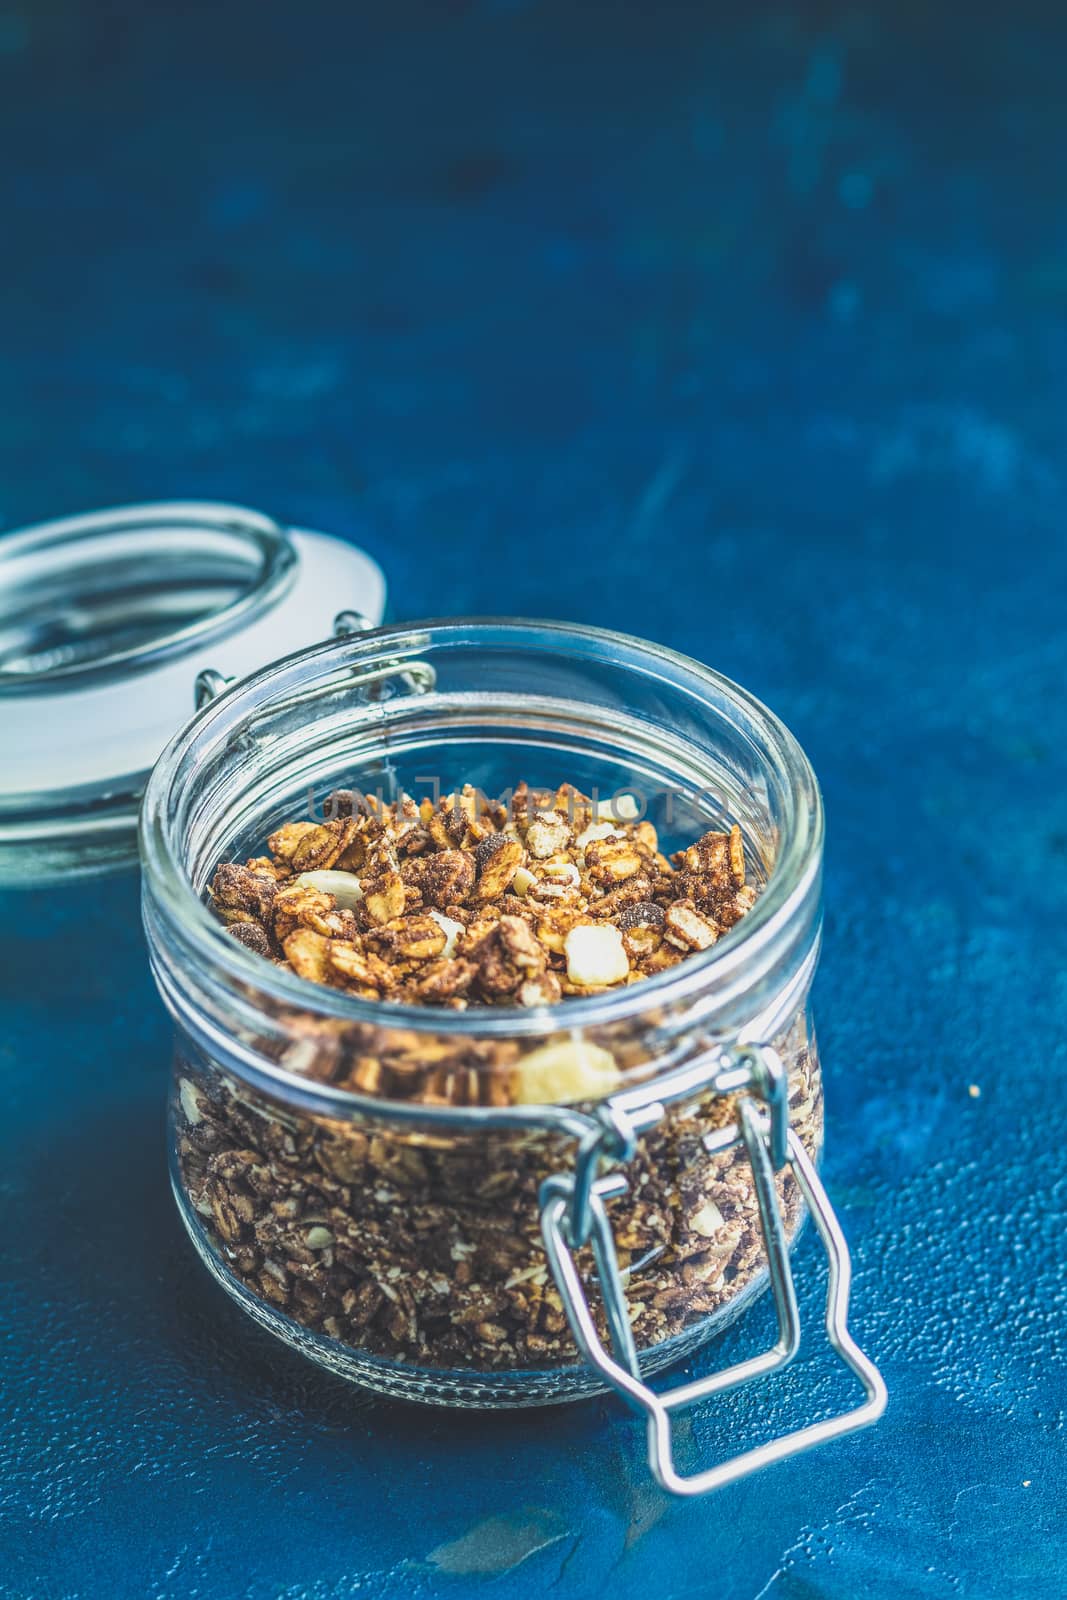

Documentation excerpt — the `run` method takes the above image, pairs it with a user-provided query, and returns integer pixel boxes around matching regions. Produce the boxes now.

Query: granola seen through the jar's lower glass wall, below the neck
[174,1018,822,1373]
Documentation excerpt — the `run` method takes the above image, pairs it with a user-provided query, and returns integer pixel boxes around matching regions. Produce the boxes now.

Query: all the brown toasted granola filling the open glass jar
[173,786,822,1373]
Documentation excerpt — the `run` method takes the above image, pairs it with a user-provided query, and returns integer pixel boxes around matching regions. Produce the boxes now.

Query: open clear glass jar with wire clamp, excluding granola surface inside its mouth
[141,621,885,1493]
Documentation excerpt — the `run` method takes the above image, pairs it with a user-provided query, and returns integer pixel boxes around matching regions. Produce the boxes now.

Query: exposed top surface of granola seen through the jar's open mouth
[211,784,755,1010]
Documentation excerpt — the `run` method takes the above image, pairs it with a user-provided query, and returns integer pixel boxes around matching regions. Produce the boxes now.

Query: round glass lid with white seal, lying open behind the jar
[0,501,386,885]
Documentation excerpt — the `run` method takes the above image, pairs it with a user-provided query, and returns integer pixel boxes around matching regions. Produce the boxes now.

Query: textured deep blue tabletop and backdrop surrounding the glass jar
[0,0,1067,1600]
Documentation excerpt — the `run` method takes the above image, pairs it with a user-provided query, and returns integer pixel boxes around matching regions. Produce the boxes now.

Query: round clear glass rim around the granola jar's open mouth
[139,616,824,1049]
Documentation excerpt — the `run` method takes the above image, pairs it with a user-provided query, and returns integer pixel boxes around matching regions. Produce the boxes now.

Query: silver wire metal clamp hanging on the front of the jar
[541,1046,886,1494]
